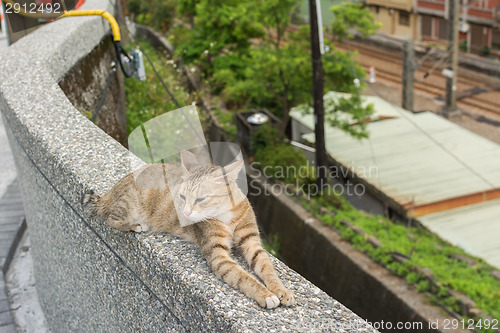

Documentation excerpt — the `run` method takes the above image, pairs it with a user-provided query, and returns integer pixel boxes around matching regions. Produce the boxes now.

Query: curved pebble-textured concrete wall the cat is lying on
[0,0,374,332]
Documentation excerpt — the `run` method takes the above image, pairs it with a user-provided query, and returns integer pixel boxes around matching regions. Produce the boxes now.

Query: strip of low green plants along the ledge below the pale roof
[303,198,500,326]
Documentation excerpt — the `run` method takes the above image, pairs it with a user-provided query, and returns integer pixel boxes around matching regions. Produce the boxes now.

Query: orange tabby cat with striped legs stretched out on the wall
[82,151,295,309]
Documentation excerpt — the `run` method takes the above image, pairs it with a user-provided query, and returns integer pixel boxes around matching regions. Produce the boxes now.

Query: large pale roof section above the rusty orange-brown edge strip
[291,100,500,206]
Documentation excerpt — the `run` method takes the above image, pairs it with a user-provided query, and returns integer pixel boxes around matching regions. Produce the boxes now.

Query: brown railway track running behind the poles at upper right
[338,42,500,115]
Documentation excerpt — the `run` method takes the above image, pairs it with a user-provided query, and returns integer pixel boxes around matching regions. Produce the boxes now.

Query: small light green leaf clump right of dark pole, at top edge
[330,2,381,42]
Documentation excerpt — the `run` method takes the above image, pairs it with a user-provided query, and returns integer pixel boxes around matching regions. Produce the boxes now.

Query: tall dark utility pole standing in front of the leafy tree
[309,0,327,190]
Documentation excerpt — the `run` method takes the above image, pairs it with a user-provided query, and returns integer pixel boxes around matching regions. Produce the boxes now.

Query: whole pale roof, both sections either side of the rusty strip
[291,92,500,267]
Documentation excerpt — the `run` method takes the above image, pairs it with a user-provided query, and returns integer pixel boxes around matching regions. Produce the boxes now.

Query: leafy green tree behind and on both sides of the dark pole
[178,0,377,138]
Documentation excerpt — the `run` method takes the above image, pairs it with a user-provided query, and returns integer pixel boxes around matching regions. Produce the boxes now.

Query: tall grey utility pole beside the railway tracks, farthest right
[444,0,460,117]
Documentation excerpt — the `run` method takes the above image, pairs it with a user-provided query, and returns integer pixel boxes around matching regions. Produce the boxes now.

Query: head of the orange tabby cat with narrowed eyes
[174,151,243,223]
